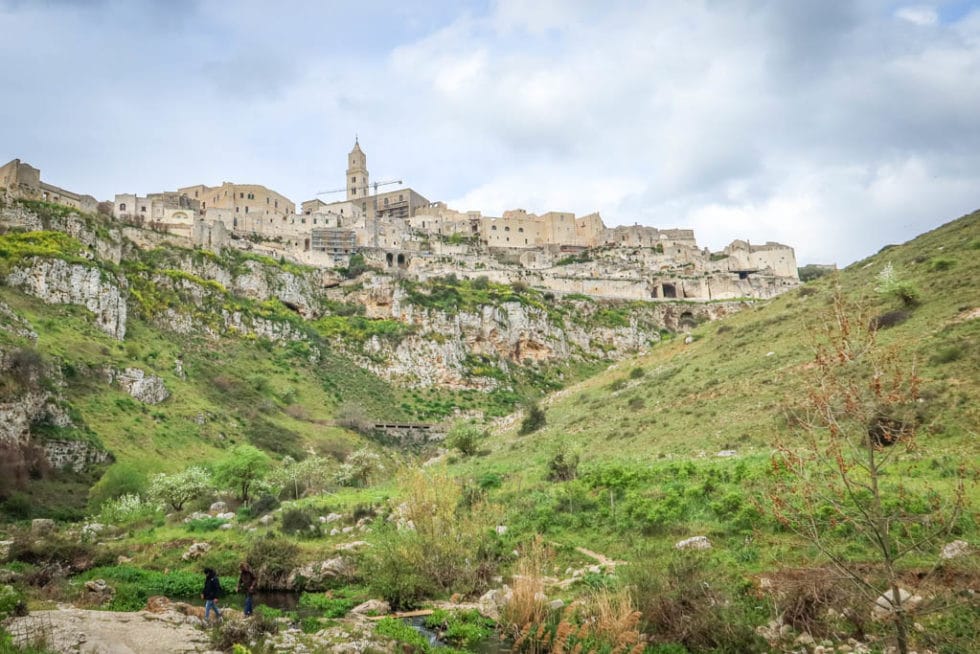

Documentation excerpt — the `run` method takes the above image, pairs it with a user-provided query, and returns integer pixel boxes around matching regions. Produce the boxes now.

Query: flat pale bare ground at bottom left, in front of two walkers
[8,607,217,654]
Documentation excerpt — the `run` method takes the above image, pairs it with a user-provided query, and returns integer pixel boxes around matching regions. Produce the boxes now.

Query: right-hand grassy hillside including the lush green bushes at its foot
[446,213,980,573]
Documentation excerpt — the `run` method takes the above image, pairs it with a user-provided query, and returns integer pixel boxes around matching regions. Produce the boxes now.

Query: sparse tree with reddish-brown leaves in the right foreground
[771,289,964,654]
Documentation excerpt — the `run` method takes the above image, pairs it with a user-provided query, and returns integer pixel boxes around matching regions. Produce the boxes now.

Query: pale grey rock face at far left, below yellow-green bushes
[5,257,126,340]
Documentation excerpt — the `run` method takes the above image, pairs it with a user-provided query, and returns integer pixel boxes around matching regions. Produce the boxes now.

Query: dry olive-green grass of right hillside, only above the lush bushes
[470,213,980,474]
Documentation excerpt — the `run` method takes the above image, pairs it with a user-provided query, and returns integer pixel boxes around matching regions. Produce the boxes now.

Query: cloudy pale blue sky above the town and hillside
[0,0,980,265]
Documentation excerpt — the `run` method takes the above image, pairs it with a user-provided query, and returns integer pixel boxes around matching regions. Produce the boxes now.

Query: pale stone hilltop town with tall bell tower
[0,141,799,301]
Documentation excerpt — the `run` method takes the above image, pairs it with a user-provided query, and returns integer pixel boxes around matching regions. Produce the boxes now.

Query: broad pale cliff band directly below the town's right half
[345,277,745,390]
